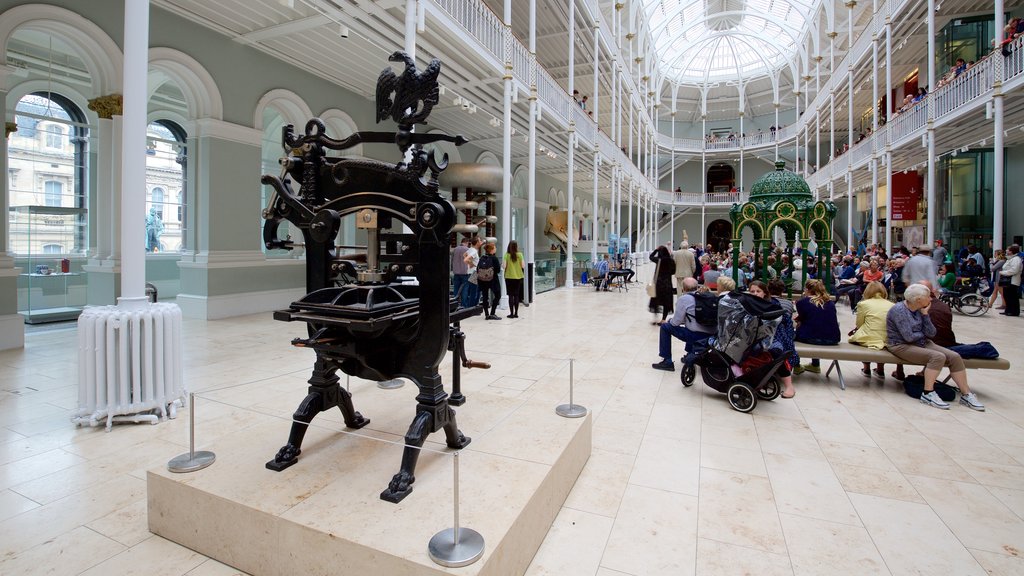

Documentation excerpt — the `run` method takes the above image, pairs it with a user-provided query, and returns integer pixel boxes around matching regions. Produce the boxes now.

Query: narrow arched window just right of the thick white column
[145,120,187,252]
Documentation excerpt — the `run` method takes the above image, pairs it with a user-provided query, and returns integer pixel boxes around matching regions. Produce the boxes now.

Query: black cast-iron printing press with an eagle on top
[262,52,488,502]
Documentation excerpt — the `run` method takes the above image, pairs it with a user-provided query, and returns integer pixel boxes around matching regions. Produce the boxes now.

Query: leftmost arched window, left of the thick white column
[7,92,89,254]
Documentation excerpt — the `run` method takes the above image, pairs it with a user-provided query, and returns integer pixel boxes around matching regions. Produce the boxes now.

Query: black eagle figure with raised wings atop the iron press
[377,50,441,128]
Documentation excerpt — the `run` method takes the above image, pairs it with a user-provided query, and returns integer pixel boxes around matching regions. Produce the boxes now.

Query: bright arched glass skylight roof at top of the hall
[643,0,820,84]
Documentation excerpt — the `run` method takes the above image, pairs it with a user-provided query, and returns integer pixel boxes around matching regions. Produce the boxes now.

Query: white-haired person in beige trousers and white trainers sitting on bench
[886,284,985,412]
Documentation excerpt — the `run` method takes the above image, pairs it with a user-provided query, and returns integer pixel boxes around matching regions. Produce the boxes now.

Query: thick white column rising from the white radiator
[118,0,150,310]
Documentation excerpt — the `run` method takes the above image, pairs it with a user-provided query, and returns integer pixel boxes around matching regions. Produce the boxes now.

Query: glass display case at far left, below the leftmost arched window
[9,206,88,324]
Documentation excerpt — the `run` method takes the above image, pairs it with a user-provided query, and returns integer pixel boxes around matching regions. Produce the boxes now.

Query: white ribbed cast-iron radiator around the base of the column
[72,302,186,431]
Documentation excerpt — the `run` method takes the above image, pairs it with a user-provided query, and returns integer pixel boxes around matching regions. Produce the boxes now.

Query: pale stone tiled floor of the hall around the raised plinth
[0,274,1024,576]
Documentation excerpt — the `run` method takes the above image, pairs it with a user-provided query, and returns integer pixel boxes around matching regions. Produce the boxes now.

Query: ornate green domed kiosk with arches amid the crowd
[729,161,836,286]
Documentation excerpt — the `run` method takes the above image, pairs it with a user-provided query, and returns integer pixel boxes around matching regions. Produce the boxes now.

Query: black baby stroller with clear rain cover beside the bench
[696,292,788,412]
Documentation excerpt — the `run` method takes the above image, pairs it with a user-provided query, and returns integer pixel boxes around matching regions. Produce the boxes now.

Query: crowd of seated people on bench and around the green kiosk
[652,236,1024,411]
